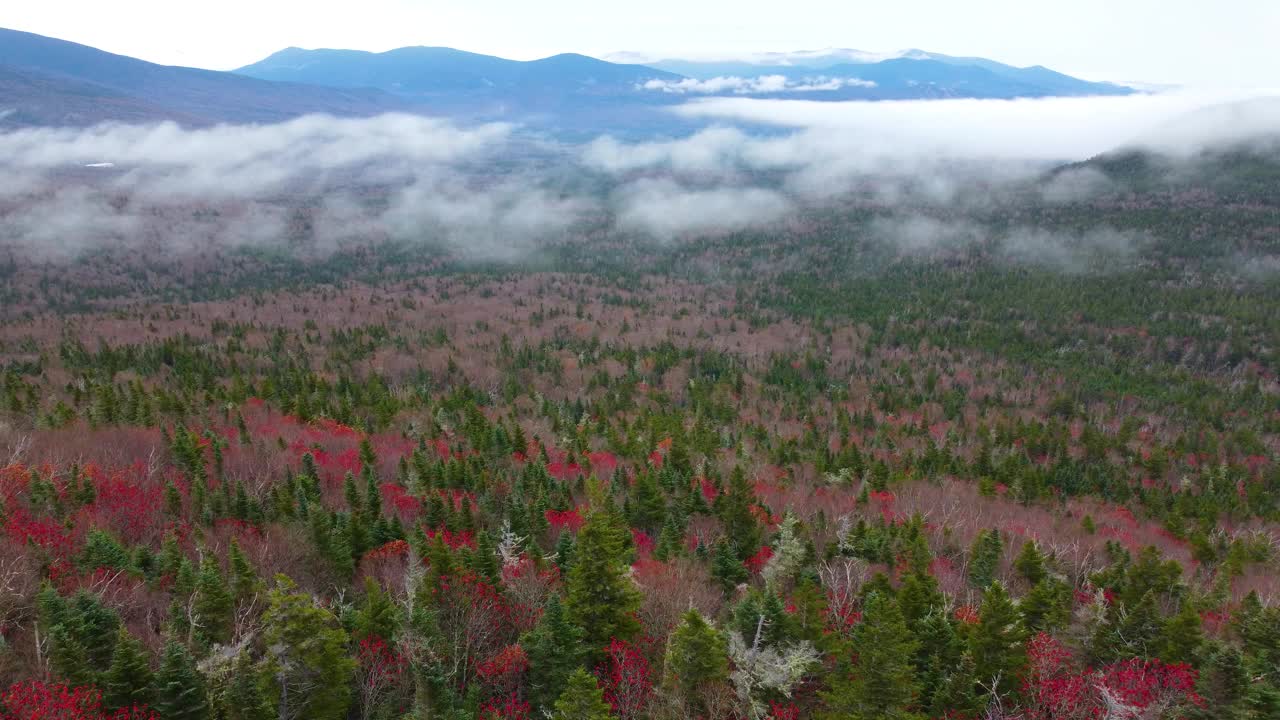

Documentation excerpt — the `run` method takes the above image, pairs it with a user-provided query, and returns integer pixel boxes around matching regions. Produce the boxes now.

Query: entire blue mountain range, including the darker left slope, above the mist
[0,28,1133,138]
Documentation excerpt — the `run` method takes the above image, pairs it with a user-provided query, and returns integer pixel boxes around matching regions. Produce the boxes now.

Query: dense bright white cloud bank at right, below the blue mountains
[675,91,1280,161]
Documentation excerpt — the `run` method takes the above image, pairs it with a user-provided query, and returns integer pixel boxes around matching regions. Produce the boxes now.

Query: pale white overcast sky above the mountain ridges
[0,0,1280,87]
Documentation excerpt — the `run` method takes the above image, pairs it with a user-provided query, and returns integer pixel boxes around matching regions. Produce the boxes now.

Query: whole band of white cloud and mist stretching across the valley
[0,89,1280,263]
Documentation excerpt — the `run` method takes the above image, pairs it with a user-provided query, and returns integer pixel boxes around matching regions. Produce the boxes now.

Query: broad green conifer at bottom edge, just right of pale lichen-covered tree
[823,593,919,720]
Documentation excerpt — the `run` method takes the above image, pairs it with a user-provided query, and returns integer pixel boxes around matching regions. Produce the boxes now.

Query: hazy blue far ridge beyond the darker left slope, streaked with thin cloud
[237,47,1134,105]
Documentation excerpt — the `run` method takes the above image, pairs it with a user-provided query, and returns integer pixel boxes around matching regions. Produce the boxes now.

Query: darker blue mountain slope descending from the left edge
[0,28,410,127]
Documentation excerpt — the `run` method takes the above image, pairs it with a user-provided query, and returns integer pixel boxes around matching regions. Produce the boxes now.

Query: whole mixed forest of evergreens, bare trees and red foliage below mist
[0,147,1280,720]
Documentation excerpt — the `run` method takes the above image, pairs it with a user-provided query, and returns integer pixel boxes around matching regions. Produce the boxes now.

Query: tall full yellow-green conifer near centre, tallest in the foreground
[564,509,640,652]
